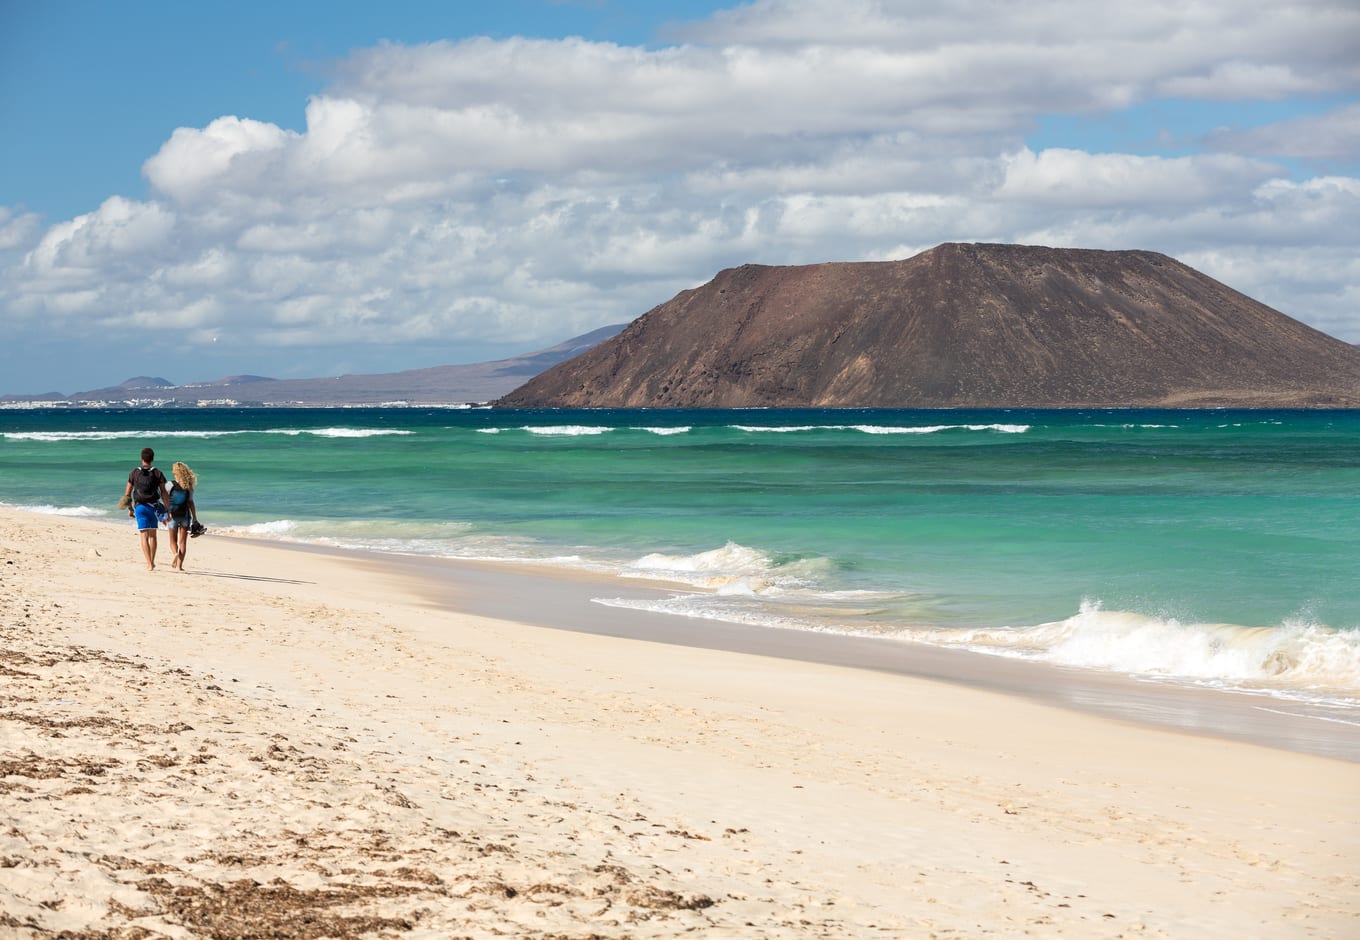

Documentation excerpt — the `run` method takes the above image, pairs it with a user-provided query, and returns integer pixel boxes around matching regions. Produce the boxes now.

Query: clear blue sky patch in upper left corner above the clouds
[0,0,722,218]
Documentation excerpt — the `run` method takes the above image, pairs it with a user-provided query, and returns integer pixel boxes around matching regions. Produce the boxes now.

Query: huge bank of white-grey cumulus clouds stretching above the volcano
[0,0,1360,391]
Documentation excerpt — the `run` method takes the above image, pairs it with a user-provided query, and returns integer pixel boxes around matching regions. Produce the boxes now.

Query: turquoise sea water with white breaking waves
[0,408,1360,702]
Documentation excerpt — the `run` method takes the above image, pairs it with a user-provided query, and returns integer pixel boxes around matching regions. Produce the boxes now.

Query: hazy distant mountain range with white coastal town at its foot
[0,324,624,407]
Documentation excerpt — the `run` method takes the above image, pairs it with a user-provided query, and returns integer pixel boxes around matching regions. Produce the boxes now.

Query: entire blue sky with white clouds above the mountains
[0,0,1360,395]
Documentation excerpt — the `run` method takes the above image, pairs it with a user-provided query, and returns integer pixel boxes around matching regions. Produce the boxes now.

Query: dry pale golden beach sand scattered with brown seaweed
[0,510,1360,940]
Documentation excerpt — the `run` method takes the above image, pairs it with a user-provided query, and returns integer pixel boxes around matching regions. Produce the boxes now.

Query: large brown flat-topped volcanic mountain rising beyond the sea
[496,244,1360,408]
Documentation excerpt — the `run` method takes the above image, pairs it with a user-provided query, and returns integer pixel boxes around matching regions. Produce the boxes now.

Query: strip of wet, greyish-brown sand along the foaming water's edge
[281,539,1360,762]
